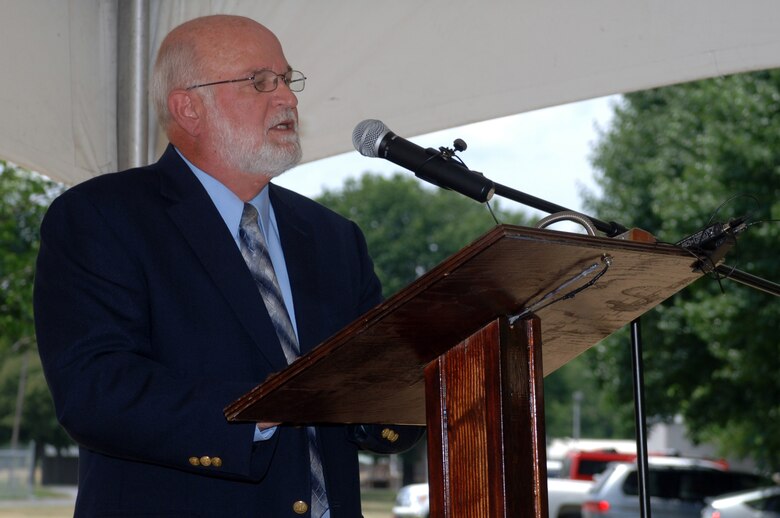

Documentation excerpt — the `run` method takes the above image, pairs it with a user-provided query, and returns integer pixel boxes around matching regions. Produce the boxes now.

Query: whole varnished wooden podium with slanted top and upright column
[225,225,701,518]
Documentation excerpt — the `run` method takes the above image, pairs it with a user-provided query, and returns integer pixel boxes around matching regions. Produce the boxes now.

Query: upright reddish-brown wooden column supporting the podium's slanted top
[425,318,548,518]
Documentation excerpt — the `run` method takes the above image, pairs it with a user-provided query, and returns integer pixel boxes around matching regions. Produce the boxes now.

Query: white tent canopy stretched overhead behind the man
[0,0,780,187]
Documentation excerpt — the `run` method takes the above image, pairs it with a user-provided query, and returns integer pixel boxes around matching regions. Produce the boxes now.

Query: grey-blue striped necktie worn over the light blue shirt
[239,203,328,518]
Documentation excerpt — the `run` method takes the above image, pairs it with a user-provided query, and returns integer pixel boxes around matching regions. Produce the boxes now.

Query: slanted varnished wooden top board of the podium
[225,225,700,424]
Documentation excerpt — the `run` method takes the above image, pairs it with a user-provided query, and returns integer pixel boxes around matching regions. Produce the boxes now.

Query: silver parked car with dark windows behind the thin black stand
[582,457,772,518]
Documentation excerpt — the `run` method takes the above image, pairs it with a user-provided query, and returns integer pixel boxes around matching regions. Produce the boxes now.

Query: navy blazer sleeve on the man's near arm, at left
[34,189,278,480]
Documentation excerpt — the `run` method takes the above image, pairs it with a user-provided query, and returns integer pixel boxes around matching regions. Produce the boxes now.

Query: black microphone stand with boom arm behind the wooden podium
[484,182,780,518]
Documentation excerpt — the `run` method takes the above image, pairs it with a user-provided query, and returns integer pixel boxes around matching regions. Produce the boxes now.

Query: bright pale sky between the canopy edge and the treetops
[275,97,618,221]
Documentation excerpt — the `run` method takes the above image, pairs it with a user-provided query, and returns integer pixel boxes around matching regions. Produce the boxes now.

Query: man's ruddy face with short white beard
[198,24,301,177]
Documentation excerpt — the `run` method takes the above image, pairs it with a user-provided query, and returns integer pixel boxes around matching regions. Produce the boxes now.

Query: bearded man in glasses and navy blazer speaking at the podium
[35,16,419,518]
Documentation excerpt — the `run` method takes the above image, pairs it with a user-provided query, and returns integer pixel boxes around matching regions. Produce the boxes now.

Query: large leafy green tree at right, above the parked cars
[588,70,780,470]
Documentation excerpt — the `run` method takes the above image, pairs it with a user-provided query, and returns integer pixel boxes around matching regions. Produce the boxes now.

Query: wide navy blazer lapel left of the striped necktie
[157,146,287,371]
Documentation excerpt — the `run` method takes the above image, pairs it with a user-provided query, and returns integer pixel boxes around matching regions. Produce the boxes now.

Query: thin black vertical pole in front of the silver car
[631,318,650,518]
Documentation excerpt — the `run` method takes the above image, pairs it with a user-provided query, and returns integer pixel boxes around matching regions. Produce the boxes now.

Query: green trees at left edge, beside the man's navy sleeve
[0,161,69,456]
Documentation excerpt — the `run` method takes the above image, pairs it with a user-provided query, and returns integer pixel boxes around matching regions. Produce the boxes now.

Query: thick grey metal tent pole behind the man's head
[116,0,149,170]
